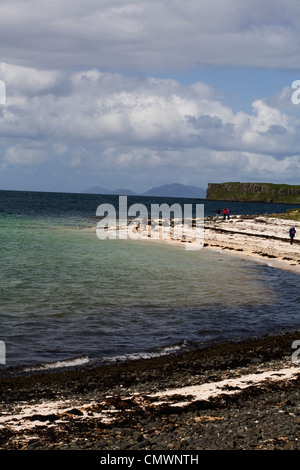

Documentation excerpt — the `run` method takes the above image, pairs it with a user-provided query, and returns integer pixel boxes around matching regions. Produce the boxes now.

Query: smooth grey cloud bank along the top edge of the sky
[0,0,300,73]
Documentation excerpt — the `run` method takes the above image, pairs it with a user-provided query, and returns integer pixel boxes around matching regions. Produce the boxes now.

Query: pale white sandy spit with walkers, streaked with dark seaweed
[132,215,300,273]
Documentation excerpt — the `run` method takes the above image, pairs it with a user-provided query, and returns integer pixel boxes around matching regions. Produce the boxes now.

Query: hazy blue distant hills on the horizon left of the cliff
[83,183,206,199]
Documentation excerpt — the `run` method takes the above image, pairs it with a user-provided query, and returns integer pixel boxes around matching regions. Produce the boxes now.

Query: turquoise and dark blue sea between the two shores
[0,191,300,375]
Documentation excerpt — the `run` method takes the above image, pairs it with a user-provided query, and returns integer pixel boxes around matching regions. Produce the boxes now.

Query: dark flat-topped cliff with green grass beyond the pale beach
[206,183,300,204]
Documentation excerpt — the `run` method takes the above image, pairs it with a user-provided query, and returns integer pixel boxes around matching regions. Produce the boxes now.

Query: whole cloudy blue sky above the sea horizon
[0,0,300,193]
